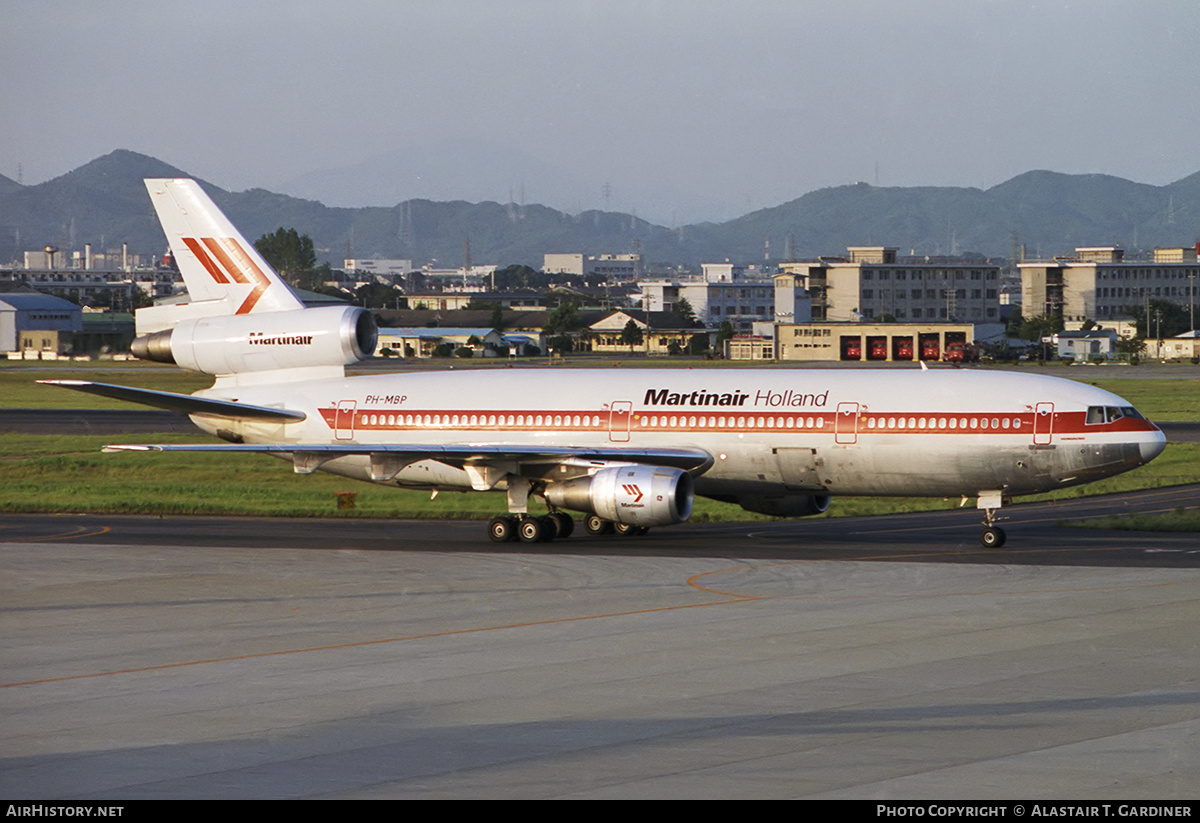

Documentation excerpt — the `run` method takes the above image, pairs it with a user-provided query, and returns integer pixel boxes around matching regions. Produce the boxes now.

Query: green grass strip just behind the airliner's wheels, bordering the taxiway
[0,432,1200,523]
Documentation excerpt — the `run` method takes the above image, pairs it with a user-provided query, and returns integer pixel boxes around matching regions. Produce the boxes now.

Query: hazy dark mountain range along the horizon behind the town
[0,150,1200,268]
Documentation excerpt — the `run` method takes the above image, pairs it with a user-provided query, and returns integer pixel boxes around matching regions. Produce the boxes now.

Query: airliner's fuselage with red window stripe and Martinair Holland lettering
[194,368,1164,498]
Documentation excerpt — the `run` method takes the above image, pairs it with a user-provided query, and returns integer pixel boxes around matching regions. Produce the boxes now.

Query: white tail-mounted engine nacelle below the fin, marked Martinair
[130,306,377,374]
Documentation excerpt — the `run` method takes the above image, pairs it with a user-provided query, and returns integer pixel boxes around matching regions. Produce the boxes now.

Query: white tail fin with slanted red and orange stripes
[145,179,304,316]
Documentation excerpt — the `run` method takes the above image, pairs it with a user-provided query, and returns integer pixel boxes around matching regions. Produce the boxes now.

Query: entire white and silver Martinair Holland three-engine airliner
[47,180,1165,547]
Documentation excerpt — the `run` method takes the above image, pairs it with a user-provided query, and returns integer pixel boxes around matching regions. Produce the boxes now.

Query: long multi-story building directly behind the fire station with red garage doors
[780,246,1001,323]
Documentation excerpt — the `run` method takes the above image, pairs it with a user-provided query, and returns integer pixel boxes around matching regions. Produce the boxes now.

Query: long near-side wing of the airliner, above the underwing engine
[104,443,713,489]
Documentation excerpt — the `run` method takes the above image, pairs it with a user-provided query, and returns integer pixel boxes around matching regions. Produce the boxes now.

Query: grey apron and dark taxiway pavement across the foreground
[0,487,1200,800]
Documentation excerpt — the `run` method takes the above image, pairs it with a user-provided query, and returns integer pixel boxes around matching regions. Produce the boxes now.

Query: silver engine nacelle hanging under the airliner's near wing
[546,465,695,527]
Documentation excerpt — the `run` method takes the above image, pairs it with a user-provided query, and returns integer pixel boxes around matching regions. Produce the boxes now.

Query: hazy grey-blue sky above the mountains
[0,0,1200,222]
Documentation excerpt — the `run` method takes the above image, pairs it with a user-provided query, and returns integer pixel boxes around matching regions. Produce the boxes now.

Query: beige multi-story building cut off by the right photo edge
[1019,246,1200,323]
